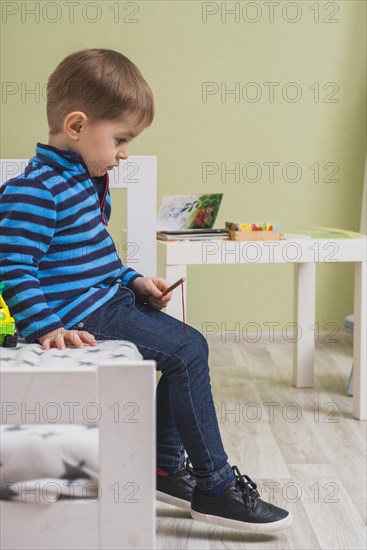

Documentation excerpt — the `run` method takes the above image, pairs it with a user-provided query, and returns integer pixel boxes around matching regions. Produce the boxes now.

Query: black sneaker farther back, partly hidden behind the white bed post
[156,458,196,510]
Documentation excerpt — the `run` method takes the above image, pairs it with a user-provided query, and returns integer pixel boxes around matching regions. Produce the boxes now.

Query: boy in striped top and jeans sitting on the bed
[0,49,292,532]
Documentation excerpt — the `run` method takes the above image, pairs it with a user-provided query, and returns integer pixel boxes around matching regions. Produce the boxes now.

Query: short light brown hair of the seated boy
[47,49,154,134]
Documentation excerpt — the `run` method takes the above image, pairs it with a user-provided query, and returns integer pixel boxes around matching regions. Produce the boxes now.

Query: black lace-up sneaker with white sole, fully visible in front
[191,466,293,533]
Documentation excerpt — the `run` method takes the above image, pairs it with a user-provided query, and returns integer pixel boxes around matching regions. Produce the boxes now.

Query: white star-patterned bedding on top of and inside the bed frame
[0,341,142,504]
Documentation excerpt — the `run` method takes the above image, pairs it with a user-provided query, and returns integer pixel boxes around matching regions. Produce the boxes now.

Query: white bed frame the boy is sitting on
[0,157,156,550]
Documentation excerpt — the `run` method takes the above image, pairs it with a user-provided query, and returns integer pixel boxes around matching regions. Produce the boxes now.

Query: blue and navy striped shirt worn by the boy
[0,143,141,342]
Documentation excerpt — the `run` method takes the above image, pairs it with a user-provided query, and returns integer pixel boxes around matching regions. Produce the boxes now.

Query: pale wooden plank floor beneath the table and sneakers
[157,342,367,550]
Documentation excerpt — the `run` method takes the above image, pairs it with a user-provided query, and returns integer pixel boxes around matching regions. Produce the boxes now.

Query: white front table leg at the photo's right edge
[353,262,367,420]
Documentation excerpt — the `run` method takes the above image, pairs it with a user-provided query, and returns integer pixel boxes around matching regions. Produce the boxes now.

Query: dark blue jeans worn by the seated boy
[73,287,232,489]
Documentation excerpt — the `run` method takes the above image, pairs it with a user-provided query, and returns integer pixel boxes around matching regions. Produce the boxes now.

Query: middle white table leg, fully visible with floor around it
[293,263,316,388]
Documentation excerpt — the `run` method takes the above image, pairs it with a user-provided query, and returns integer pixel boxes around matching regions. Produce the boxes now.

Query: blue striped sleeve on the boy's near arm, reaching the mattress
[0,177,63,342]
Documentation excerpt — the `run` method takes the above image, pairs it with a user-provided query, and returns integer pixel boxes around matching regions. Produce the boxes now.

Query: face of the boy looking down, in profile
[73,116,145,177]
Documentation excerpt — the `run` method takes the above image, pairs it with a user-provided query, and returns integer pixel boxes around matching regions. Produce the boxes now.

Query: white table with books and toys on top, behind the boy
[157,228,367,420]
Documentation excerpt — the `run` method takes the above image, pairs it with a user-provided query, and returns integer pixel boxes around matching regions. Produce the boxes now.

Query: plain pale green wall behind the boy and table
[1,0,366,336]
